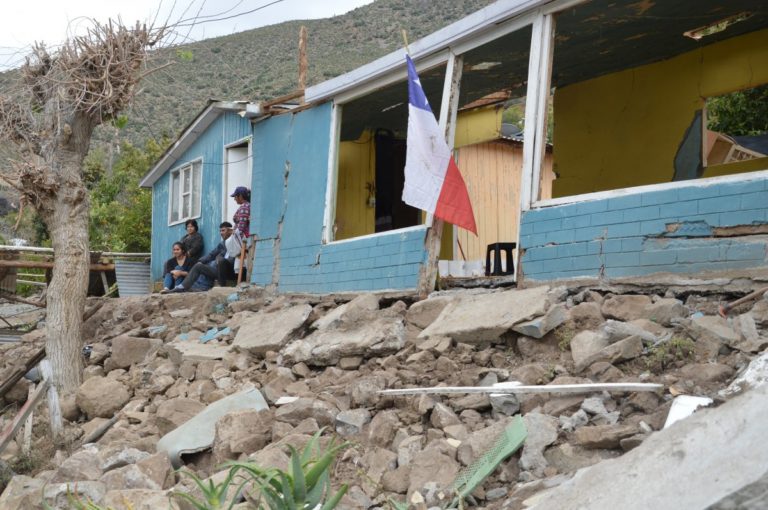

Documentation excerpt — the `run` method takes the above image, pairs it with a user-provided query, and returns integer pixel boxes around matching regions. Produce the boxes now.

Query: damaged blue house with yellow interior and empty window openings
[142,0,768,292]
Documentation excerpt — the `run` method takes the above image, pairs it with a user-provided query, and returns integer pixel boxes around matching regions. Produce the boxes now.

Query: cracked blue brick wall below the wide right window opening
[520,176,768,280]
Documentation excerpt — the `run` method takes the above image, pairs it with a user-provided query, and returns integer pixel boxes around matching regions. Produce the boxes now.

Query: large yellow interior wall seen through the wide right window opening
[553,30,768,197]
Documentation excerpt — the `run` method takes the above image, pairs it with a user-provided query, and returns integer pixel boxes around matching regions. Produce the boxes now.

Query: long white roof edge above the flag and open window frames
[305,0,552,103]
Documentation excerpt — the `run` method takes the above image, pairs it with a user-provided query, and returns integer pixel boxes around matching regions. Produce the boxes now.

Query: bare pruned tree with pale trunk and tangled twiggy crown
[0,21,164,393]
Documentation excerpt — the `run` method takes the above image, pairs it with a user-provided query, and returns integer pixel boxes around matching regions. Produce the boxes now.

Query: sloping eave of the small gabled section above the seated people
[139,99,264,188]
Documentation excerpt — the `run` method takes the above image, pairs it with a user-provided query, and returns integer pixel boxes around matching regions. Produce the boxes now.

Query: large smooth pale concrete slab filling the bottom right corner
[534,387,768,510]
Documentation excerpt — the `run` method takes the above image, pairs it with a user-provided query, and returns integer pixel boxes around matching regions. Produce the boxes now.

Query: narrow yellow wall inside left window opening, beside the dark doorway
[335,131,376,240]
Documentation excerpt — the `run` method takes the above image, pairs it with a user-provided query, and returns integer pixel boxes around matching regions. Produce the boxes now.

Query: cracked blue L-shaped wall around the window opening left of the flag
[251,103,426,293]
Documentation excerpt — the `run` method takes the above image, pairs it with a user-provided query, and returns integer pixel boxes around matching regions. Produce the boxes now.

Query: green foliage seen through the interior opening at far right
[707,85,768,136]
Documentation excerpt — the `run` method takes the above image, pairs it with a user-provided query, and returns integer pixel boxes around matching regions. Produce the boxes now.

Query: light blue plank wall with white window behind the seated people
[152,113,251,280]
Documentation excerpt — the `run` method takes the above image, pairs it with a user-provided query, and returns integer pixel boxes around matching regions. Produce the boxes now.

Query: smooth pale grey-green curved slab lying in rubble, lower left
[157,388,268,468]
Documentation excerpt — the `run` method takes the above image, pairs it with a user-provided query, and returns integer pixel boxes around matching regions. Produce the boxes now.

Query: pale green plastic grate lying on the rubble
[451,415,528,508]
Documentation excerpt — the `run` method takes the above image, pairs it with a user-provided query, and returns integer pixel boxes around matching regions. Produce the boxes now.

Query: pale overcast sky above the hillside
[0,0,373,71]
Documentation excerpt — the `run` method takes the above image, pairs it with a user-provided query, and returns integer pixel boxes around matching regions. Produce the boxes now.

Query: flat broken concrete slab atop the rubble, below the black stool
[419,286,549,344]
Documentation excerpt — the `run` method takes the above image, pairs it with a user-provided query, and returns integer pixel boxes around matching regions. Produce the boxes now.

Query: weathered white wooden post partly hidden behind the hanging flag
[417,52,463,299]
